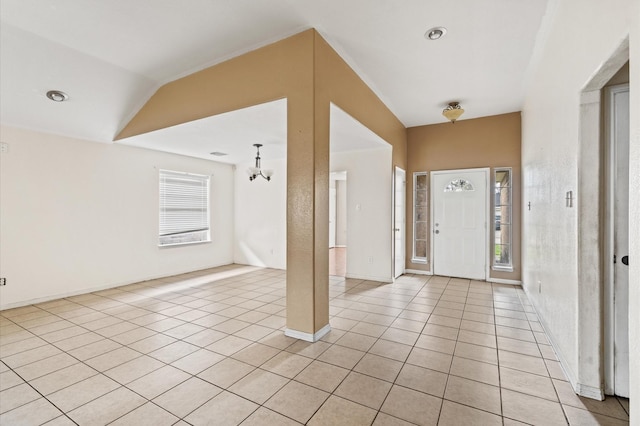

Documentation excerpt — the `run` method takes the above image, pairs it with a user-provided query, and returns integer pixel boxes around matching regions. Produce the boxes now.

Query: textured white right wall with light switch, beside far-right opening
[522,0,640,406]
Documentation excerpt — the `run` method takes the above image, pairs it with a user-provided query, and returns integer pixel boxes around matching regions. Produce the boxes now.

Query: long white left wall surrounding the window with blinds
[0,127,234,309]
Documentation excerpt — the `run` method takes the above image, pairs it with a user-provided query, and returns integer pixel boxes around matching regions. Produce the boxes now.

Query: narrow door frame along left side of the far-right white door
[602,83,630,395]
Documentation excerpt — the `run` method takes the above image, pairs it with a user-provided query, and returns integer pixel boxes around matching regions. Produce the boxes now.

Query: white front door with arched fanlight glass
[431,169,489,280]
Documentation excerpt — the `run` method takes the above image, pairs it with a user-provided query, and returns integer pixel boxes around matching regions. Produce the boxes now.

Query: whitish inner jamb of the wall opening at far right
[576,38,633,400]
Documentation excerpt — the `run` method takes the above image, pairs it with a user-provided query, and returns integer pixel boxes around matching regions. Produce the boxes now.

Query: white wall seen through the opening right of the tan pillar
[330,146,393,282]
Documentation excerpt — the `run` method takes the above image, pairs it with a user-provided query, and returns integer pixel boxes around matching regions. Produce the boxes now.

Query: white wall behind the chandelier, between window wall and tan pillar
[233,159,287,269]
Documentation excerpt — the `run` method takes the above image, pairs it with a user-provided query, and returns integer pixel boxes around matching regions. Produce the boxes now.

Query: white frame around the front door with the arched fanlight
[429,167,491,281]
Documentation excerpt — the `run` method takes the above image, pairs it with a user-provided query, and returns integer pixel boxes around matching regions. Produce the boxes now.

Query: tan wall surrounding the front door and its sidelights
[406,112,521,280]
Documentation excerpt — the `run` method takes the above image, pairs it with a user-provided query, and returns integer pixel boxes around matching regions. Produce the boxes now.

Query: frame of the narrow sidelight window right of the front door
[491,167,513,272]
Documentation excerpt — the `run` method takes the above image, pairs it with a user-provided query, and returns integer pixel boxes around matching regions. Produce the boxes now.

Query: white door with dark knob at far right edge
[605,84,629,397]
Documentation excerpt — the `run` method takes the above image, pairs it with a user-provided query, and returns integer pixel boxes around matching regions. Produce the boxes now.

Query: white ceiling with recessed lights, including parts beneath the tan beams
[0,0,547,162]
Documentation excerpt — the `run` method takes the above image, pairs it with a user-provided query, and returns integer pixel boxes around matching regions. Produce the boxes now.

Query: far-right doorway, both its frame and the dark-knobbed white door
[604,84,629,398]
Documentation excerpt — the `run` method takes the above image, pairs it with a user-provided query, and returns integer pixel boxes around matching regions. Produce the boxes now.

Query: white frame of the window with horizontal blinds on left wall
[157,169,211,248]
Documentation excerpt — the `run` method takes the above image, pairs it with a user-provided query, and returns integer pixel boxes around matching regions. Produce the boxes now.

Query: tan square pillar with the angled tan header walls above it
[117,30,406,334]
